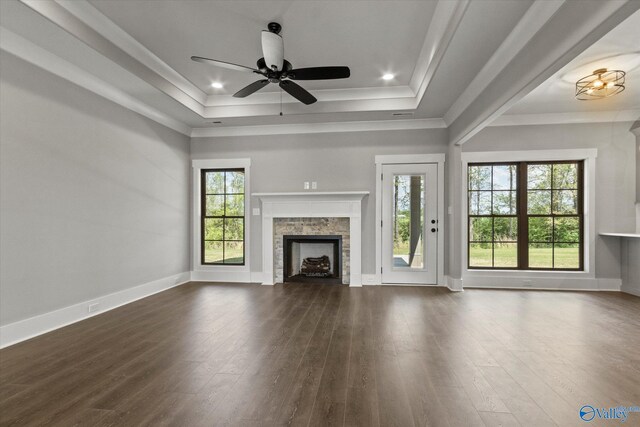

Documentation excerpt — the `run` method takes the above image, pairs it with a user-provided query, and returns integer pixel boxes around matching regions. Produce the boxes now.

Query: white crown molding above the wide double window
[488,110,640,126]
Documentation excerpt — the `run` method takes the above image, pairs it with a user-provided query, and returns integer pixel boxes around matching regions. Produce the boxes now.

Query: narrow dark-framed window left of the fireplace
[200,169,245,265]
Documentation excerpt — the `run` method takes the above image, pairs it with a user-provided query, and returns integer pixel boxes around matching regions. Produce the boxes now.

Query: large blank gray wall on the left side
[0,53,190,325]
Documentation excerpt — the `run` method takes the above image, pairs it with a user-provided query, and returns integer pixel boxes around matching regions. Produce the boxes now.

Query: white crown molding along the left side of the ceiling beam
[444,0,565,125]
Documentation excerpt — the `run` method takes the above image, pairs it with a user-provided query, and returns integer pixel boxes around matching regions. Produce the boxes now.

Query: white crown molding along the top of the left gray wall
[0,26,191,136]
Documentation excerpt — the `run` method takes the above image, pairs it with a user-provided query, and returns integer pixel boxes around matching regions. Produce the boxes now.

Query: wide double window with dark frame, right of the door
[468,161,584,271]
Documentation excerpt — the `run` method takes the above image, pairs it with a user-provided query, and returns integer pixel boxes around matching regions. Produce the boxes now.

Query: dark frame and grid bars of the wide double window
[466,160,585,272]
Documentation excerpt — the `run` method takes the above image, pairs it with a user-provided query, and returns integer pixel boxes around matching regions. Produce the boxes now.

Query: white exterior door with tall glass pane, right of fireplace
[381,163,438,284]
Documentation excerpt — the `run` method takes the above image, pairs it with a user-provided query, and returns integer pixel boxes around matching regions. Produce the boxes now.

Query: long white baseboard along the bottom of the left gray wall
[0,271,191,348]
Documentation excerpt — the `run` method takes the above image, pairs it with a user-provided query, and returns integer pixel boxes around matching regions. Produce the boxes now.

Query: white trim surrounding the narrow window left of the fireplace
[191,159,251,282]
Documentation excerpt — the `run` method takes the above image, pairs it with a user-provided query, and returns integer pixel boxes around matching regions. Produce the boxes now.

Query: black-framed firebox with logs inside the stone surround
[282,235,342,284]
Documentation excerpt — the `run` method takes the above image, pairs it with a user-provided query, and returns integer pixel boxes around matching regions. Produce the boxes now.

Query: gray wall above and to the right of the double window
[463,123,636,279]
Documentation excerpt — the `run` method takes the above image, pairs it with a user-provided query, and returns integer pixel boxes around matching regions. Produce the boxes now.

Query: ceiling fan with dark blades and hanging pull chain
[191,22,351,105]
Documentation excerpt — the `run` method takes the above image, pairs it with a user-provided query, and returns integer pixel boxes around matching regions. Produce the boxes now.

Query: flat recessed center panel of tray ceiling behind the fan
[91,0,436,94]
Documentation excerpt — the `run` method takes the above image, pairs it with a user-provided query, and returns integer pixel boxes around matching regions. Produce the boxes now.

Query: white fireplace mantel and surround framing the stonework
[252,191,369,286]
